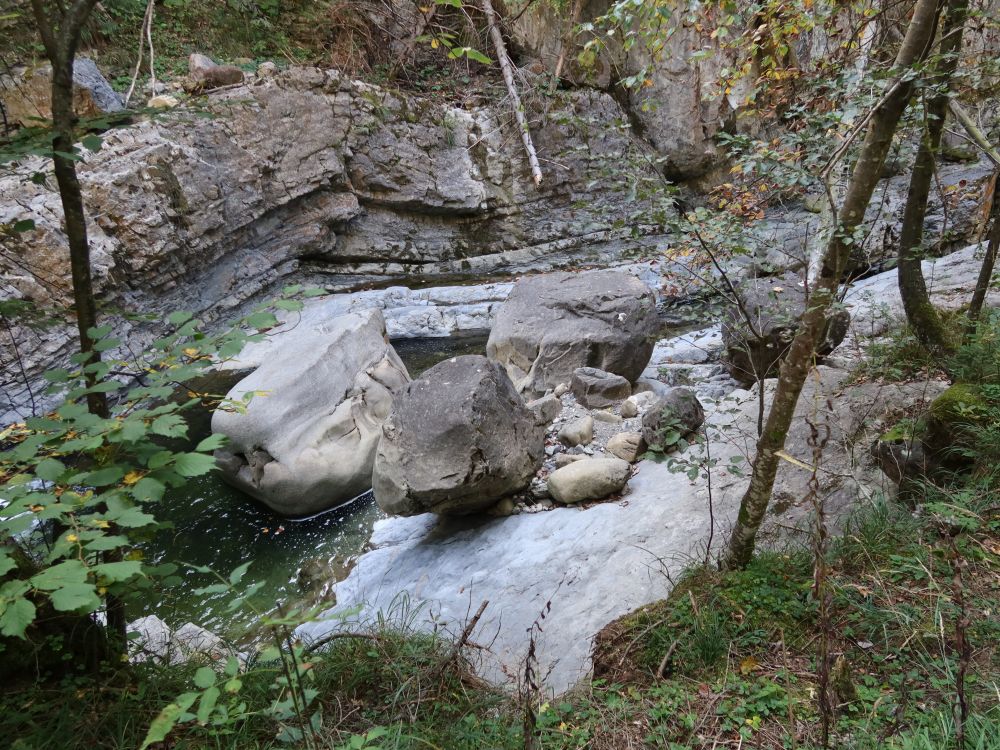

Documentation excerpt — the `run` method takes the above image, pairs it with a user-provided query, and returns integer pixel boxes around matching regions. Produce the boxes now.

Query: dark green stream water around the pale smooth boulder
[129,332,487,640]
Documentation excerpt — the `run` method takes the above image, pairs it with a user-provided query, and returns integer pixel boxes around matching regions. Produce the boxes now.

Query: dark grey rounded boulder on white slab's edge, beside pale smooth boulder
[372,355,545,516]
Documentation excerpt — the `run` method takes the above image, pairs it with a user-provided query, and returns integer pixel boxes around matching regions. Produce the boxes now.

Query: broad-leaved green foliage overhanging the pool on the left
[0,287,312,638]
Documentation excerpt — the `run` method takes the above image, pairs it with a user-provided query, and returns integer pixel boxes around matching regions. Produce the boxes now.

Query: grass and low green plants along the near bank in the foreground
[0,482,1000,750]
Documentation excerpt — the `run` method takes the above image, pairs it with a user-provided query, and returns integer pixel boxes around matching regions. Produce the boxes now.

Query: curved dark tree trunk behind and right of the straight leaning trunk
[896,0,968,357]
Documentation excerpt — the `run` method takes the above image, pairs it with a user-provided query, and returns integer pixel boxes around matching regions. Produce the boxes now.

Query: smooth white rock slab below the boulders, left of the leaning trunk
[299,391,756,693]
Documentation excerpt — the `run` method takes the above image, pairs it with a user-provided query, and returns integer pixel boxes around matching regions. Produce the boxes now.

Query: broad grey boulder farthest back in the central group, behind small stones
[486,271,658,395]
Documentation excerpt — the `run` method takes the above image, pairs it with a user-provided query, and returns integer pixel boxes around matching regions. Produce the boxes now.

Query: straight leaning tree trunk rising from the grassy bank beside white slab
[720,0,938,569]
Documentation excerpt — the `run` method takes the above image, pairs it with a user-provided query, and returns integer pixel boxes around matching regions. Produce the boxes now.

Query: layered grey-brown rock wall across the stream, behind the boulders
[0,68,662,419]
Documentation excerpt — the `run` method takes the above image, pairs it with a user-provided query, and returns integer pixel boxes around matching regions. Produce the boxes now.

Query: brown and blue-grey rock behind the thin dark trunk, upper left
[0,57,124,127]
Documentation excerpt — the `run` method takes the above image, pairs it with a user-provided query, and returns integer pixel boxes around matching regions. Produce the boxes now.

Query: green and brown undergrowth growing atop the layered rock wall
[0,0,496,95]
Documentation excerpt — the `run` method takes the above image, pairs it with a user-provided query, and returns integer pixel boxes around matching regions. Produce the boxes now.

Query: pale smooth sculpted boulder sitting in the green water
[212,310,410,516]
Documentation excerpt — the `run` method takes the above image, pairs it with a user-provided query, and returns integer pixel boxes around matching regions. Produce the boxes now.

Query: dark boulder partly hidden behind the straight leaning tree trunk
[722,273,851,383]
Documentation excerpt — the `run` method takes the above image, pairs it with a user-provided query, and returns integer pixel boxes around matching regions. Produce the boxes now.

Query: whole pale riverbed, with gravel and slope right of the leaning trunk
[282,247,984,692]
